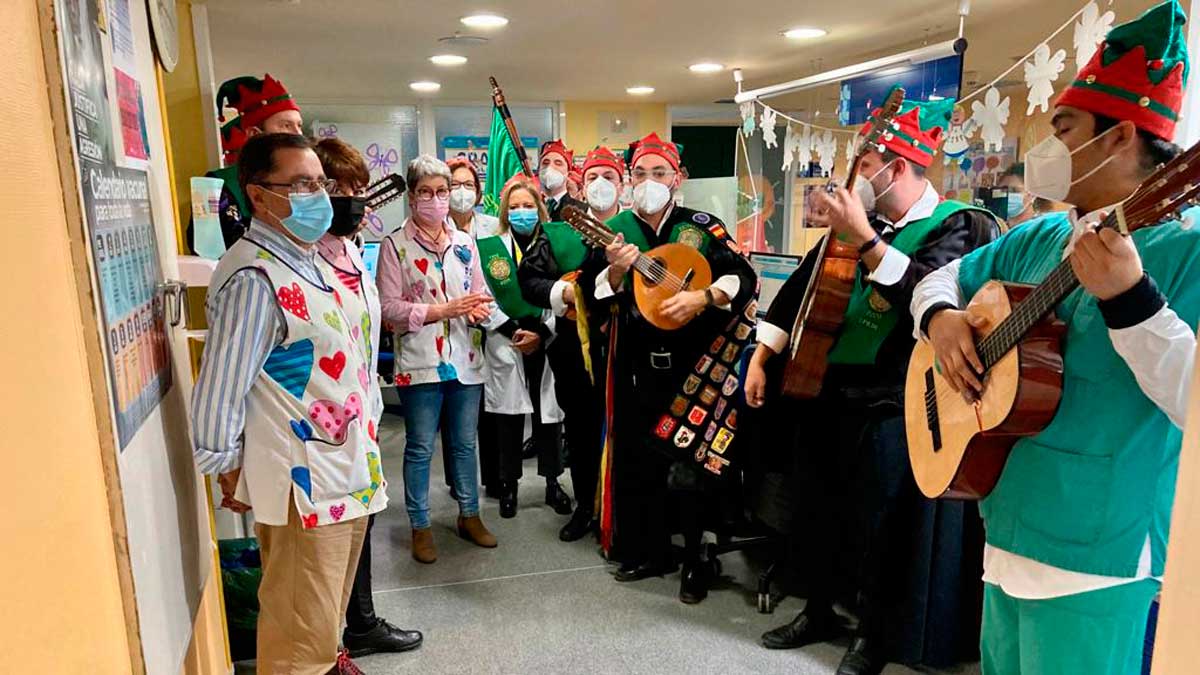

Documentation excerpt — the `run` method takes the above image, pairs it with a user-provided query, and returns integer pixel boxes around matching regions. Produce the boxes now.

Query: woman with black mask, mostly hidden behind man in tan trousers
[314,138,422,658]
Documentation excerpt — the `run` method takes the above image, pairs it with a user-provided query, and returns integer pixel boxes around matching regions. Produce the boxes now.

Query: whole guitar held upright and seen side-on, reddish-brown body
[782,86,904,399]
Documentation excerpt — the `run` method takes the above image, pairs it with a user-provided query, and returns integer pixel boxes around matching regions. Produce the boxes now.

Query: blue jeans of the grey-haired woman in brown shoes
[400,380,484,528]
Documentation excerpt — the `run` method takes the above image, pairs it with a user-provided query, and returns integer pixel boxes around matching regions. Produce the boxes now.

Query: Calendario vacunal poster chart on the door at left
[83,166,170,449]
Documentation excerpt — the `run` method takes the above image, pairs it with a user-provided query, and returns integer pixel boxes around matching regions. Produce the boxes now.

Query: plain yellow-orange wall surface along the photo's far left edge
[0,0,131,675]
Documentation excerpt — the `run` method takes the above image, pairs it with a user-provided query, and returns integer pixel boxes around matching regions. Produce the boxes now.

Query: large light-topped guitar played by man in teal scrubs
[905,144,1200,500]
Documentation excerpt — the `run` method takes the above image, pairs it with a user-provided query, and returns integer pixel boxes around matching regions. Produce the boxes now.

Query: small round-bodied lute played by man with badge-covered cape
[563,205,713,330]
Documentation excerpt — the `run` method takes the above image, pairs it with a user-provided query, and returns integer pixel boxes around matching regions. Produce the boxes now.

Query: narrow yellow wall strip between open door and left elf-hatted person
[162,0,215,252]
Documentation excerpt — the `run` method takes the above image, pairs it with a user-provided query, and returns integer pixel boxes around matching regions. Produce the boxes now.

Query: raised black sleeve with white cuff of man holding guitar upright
[869,210,1000,306]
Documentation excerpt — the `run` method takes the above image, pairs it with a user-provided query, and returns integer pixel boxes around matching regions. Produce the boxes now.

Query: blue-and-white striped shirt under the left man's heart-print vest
[192,219,325,473]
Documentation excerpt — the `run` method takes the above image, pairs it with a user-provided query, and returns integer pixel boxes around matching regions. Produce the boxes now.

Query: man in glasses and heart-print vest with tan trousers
[192,133,388,674]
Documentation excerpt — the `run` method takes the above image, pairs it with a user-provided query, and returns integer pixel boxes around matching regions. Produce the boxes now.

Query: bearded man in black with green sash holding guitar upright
[746,100,998,675]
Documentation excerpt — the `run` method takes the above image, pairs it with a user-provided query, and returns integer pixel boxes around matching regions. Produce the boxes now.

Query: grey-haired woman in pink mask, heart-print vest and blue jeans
[378,155,496,563]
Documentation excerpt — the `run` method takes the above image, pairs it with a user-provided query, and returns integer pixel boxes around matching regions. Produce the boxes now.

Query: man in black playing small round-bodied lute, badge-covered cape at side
[589,133,756,604]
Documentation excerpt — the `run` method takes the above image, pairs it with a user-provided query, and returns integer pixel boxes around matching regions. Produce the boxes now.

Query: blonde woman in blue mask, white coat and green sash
[479,179,571,518]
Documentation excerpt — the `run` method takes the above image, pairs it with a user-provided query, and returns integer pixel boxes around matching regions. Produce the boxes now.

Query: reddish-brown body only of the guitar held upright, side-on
[781,239,858,399]
